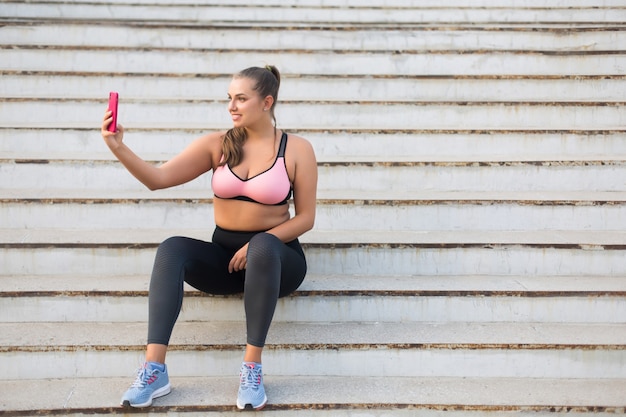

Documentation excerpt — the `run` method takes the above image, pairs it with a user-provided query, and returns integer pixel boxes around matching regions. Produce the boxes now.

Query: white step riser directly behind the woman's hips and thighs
[0,240,626,277]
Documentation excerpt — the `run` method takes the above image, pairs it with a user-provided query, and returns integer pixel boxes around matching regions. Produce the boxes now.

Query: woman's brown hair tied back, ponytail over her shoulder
[220,65,280,167]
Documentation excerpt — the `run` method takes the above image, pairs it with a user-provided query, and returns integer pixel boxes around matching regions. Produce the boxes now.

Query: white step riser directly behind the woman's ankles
[0,348,626,380]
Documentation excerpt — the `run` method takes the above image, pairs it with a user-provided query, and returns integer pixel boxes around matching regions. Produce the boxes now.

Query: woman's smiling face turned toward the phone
[228,78,268,127]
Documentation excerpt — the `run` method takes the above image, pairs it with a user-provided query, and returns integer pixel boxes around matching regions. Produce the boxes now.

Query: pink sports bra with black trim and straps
[211,132,292,206]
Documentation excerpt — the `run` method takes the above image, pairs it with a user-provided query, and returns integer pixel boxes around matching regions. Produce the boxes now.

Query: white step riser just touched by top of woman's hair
[0,48,626,76]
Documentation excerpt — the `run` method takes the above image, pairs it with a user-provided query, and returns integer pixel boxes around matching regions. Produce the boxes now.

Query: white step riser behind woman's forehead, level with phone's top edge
[7,72,626,104]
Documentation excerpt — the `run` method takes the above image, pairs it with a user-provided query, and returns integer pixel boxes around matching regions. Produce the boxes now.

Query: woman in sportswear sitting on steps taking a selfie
[101,66,317,409]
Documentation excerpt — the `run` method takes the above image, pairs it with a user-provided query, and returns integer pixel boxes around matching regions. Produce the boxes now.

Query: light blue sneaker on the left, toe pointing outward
[121,363,171,407]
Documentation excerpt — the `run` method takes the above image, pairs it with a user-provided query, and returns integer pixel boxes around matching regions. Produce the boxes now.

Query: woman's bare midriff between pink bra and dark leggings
[213,198,290,232]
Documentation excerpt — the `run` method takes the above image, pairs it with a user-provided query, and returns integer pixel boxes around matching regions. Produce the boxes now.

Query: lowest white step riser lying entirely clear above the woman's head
[0,22,626,53]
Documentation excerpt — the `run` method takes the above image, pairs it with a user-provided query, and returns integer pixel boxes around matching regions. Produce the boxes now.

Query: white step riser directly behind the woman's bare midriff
[0,201,626,234]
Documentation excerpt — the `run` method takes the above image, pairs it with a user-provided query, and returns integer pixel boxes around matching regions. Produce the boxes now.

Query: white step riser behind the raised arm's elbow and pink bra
[0,164,626,193]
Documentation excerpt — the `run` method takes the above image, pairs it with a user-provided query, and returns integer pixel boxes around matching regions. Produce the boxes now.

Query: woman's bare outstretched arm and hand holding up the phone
[101,111,221,190]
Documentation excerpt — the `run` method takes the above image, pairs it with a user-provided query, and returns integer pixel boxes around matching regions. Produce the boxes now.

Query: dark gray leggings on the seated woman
[148,227,307,347]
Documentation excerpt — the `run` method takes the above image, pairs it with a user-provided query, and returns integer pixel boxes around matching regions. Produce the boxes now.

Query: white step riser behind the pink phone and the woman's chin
[0,99,626,130]
